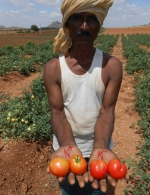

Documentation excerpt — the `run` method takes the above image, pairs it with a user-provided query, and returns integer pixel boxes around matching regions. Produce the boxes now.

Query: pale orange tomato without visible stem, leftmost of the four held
[49,156,69,177]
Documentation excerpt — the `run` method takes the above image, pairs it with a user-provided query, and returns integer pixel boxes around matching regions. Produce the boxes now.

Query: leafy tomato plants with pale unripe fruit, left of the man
[0,78,52,140]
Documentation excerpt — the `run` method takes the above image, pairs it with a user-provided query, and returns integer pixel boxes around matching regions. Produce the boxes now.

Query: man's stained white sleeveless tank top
[53,49,113,157]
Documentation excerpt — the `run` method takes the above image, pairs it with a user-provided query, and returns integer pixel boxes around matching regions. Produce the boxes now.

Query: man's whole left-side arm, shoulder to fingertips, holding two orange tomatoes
[44,59,88,187]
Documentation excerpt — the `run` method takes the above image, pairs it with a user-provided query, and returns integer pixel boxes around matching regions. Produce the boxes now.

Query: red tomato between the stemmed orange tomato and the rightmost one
[90,159,107,179]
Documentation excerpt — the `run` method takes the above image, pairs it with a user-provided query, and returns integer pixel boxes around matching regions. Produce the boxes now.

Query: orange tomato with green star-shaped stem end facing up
[69,155,87,175]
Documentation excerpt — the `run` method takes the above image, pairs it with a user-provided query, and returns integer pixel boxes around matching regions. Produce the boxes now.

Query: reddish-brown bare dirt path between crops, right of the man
[107,36,141,195]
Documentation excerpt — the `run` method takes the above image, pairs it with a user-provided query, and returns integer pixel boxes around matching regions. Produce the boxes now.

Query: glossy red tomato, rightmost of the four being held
[108,158,127,179]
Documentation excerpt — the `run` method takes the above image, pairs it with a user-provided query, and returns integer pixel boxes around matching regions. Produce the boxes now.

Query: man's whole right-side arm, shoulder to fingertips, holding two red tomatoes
[89,57,126,192]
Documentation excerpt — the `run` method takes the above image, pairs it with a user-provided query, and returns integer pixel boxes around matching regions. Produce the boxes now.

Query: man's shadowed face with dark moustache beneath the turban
[66,12,100,43]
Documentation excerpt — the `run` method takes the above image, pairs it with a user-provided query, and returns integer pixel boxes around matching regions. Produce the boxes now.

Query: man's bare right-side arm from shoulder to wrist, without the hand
[93,57,122,149]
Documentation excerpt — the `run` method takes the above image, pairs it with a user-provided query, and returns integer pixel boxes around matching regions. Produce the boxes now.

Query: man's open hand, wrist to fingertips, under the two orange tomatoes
[47,145,88,188]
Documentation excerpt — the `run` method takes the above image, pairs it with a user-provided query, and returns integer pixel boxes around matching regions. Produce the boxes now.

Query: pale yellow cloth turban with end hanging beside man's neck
[54,0,113,54]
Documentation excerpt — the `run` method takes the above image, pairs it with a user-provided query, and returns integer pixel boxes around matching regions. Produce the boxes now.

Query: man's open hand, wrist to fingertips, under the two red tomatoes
[88,148,128,193]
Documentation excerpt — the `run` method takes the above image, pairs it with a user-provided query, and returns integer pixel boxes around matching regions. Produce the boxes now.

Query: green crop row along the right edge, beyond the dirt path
[122,35,150,195]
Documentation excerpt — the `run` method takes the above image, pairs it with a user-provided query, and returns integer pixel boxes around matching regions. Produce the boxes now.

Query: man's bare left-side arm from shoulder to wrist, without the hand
[44,59,76,147]
